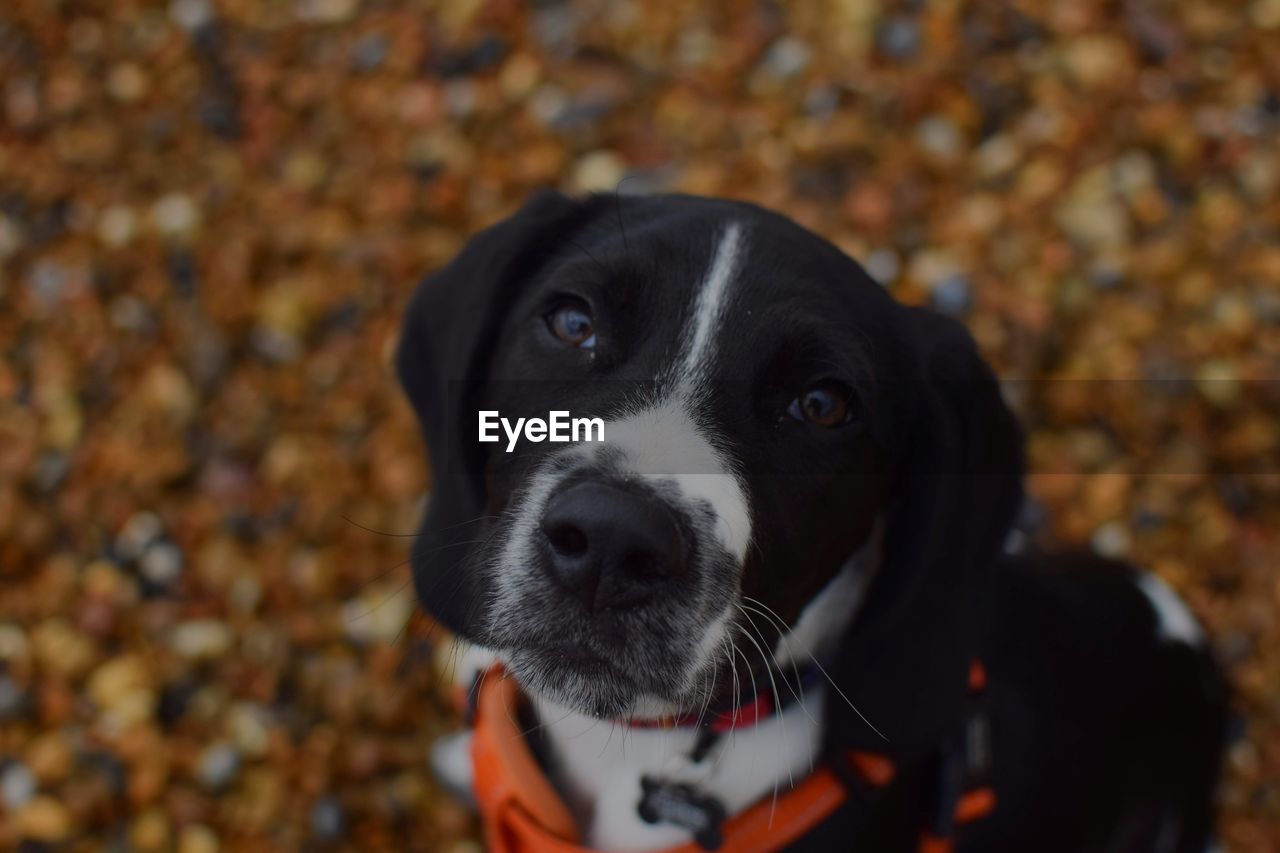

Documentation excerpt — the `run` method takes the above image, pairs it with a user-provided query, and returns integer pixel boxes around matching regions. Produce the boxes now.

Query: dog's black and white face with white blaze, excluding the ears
[483,207,884,715]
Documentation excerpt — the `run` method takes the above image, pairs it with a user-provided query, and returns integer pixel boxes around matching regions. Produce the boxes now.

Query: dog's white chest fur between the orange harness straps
[536,689,823,852]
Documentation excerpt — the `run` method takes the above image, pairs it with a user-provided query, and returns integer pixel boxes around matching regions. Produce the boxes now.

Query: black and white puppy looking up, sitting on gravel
[397,193,1225,852]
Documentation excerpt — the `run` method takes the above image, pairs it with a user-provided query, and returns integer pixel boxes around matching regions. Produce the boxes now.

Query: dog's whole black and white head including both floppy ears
[397,193,1021,749]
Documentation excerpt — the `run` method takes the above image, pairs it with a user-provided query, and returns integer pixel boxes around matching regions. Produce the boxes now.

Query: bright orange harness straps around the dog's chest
[471,667,995,853]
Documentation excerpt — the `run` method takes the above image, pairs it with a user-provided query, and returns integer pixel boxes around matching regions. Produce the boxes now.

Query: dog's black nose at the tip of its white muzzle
[541,482,686,610]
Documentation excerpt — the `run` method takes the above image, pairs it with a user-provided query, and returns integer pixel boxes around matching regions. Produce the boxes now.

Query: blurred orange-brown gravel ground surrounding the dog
[0,0,1280,853]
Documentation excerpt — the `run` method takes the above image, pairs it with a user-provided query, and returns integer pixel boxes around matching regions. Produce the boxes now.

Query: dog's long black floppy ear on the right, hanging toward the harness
[827,309,1023,757]
